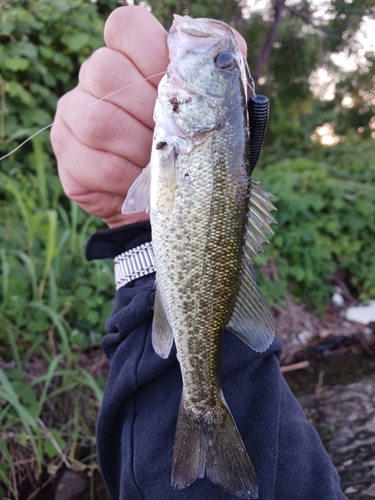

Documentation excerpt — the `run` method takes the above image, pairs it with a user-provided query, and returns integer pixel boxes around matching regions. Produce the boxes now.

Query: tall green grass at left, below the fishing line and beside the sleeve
[0,138,113,499]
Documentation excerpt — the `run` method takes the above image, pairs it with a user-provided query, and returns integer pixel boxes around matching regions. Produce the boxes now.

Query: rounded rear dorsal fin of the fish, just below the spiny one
[227,260,275,352]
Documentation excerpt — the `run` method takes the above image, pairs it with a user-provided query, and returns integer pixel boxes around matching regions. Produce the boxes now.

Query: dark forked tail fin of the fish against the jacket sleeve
[172,395,258,500]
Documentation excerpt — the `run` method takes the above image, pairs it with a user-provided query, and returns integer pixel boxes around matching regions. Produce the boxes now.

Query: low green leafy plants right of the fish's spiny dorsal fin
[256,142,375,311]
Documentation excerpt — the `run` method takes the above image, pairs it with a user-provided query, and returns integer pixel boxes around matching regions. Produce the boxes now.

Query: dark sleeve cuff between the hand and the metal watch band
[85,221,151,261]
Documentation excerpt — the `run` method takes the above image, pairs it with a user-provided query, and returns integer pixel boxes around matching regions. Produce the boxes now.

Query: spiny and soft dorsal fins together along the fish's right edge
[227,179,276,352]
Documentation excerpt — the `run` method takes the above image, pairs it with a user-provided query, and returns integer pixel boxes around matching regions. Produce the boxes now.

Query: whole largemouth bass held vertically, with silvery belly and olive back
[123,16,275,499]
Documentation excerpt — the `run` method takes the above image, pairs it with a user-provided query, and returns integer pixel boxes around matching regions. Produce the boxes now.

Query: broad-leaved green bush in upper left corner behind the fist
[0,0,118,153]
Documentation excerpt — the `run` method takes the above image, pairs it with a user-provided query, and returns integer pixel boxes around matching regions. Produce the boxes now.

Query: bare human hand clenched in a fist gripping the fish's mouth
[51,6,246,227]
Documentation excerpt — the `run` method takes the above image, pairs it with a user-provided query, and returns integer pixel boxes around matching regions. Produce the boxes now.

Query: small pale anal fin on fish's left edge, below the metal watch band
[152,288,173,359]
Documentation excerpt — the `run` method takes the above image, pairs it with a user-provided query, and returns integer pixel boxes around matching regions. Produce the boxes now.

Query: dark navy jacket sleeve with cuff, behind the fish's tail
[86,222,346,500]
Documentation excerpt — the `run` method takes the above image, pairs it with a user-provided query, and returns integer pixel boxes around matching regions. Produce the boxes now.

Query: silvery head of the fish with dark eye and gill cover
[154,16,254,147]
